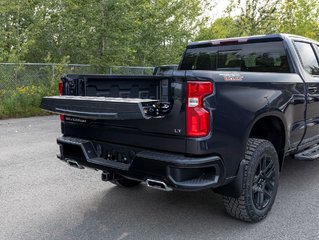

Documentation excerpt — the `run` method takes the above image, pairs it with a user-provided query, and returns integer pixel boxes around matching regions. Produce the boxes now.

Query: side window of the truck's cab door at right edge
[295,42,319,75]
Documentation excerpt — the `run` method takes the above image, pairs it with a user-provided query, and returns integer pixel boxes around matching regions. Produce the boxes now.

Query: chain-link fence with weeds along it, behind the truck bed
[0,63,154,119]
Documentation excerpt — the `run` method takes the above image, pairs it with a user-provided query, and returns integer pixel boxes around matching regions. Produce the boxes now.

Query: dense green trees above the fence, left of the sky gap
[0,0,210,66]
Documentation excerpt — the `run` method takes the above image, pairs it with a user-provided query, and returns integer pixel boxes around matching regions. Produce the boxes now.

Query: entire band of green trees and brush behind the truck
[0,0,319,117]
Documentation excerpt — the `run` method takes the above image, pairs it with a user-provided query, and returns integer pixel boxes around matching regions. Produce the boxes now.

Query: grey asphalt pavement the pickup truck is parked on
[0,116,319,240]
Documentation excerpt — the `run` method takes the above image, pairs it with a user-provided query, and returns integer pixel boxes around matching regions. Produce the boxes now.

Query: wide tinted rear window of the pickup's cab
[180,42,290,73]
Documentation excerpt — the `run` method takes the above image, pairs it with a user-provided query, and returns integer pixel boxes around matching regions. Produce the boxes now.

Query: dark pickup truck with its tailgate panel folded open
[41,34,319,222]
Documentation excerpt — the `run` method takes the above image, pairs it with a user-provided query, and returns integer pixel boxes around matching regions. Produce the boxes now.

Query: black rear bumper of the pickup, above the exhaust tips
[57,137,228,190]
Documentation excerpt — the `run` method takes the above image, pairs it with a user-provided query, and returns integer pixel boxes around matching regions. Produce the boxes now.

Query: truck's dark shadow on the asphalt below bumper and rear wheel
[53,156,319,239]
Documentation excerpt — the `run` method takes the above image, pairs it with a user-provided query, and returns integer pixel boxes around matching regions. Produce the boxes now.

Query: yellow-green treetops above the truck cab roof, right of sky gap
[196,0,319,40]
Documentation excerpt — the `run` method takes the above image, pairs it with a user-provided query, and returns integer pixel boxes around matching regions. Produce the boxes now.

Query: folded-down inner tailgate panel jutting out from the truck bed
[40,96,161,120]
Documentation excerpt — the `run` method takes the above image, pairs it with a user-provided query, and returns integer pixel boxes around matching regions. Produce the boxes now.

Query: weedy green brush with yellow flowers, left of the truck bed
[0,64,59,119]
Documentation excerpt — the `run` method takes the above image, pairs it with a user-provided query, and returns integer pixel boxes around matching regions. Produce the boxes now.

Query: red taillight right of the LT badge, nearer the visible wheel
[186,81,214,137]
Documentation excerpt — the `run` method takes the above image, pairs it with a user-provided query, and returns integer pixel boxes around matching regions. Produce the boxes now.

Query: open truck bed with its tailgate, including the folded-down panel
[41,75,186,153]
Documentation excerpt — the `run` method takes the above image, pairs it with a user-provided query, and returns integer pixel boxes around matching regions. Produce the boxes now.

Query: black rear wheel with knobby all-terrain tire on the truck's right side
[224,138,279,222]
